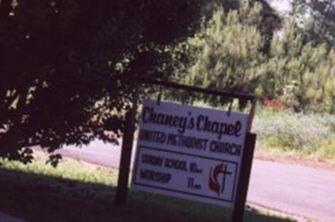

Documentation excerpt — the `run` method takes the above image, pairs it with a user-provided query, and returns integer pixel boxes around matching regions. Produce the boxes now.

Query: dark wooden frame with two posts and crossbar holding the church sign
[114,78,256,222]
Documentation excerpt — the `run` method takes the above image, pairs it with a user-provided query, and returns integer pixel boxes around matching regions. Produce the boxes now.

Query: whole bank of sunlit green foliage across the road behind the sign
[176,1,335,113]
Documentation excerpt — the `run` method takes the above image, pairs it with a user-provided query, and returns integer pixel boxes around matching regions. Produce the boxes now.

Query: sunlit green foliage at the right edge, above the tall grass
[258,21,335,112]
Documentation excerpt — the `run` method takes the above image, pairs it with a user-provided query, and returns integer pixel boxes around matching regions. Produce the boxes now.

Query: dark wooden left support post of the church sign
[114,90,138,206]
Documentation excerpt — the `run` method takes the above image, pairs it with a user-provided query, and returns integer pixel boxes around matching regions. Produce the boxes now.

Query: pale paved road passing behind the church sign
[61,141,335,222]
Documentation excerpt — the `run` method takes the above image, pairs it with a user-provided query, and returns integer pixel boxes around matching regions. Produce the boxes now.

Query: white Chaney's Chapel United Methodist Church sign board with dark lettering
[132,100,248,207]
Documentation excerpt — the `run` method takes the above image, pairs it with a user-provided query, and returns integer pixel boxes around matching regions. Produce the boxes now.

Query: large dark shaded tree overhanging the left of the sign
[0,0,207,161]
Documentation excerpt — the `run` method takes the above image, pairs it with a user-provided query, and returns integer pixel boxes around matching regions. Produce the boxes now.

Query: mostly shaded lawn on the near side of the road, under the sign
[0,154,292,222]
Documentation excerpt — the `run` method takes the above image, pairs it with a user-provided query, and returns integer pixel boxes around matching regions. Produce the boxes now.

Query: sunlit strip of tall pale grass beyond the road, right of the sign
[253,109,335,161]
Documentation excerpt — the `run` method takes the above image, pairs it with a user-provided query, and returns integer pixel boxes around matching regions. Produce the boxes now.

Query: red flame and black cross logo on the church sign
[208,163,231,197]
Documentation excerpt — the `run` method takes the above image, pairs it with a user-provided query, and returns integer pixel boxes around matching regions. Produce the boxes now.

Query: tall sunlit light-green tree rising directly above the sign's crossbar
[177,1,279,96]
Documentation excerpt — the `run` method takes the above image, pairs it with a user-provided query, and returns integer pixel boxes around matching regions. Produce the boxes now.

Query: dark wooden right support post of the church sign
[231,133,256,222]
